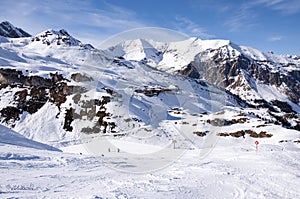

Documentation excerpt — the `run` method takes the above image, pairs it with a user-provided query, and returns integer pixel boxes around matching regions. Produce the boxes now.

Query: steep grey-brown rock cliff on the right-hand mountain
[192,47,300,104]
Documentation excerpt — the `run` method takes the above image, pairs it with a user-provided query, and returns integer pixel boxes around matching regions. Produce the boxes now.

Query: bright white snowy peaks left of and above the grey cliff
[108,37,230,72]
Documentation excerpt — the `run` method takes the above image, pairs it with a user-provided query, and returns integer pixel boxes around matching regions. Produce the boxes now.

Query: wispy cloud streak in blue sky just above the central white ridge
[174,16,215,39]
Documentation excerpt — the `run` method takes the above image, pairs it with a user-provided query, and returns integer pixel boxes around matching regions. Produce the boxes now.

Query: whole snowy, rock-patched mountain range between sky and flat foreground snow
[0,22,300,146]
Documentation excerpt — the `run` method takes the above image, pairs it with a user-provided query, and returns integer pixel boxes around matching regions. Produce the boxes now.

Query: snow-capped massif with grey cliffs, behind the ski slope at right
[109,38,300,104]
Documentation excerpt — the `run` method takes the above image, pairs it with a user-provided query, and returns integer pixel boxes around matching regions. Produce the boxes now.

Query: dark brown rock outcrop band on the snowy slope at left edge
[0,68,86,131]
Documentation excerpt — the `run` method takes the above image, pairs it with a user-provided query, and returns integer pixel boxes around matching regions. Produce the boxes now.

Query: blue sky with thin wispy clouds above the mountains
[0,0,300,54]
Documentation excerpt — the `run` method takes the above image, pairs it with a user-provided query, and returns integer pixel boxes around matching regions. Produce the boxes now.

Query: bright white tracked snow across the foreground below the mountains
[0,124,300,198]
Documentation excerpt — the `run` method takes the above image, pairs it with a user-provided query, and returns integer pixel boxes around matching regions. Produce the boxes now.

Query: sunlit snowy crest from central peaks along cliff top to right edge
[108,37,300,71]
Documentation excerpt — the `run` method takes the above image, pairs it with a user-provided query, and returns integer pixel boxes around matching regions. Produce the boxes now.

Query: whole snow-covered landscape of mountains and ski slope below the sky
[0,25,300,198]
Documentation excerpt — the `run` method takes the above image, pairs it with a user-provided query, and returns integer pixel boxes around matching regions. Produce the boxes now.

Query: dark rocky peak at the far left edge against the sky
[0,21,31,38]
